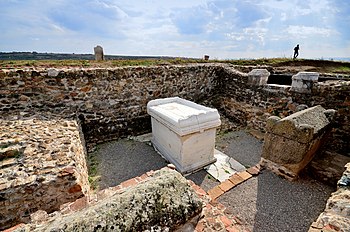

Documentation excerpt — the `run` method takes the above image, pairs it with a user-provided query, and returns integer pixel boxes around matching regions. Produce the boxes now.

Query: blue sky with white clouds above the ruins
[0,0,350,59]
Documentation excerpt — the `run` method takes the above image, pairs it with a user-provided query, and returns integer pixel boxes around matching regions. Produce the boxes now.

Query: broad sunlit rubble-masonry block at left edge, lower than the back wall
[0,118,89,229]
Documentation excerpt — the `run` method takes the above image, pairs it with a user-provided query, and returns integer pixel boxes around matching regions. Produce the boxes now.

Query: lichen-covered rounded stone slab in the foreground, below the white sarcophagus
[15,169,203,232]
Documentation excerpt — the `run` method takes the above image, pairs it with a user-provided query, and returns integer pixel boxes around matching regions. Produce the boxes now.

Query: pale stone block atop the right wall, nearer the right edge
[291,72,319,93]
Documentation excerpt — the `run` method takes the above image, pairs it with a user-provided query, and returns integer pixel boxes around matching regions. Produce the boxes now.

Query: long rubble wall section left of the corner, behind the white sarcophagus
[0,65,217,150]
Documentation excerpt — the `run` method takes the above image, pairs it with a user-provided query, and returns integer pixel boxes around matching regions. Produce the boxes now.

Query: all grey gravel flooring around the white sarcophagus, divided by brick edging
[91,131,335,232]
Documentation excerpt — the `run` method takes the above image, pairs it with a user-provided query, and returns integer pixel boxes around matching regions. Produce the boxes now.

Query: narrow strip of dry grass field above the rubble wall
[0,58,350,74]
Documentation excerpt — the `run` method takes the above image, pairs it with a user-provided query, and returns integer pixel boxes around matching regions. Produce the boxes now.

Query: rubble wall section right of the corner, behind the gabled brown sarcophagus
[216,69,350,156]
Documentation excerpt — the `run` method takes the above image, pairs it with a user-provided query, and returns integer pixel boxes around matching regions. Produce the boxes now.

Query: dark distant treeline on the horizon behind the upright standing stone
[0,52,179,60]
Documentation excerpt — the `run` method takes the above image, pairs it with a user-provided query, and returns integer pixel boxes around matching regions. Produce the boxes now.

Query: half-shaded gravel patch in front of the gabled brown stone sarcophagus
[218,170,334,232]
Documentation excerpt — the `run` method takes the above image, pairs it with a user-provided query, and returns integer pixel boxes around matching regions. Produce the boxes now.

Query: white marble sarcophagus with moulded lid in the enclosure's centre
[147,97,221,173]
